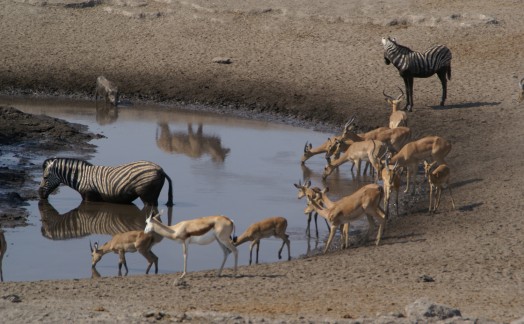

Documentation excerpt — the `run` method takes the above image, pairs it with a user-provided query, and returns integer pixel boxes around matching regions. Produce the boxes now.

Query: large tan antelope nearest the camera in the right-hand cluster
[304,184,386,253]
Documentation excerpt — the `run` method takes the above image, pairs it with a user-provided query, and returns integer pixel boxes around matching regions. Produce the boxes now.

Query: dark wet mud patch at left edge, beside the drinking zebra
[0,106,103,227]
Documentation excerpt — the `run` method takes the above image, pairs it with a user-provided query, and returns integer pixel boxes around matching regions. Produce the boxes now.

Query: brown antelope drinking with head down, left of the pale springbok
[89,230,163,276]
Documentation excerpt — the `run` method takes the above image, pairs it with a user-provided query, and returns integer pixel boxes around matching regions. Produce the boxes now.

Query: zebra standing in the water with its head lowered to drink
[38,158,173,207]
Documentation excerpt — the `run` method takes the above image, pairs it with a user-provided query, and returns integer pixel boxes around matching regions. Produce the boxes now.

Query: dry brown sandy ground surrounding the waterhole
[0,0,524,322]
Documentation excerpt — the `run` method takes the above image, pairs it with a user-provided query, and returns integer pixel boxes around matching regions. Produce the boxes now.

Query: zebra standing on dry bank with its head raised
[382,37,451,111]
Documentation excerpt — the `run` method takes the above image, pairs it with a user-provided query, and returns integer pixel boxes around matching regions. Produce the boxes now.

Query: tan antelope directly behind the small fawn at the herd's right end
[390,136,451,192]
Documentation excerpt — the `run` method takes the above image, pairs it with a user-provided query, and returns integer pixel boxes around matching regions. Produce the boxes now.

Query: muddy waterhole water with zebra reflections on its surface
[1,98,370,281]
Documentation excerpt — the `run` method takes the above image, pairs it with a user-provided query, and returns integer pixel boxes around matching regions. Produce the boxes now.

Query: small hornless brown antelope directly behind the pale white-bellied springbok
[233,217,291,265]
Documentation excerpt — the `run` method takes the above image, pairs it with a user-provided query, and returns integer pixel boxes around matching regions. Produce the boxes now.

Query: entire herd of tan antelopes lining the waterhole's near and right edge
[84,90,455,278]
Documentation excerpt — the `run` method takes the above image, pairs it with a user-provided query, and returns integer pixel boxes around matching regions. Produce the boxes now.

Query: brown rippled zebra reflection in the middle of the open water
[156,122,230,162]
